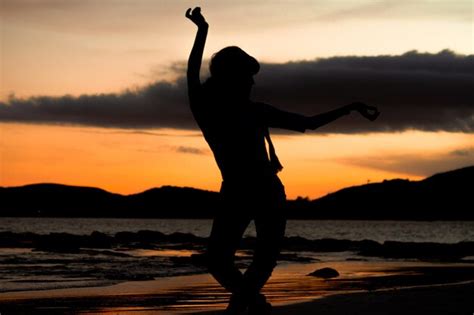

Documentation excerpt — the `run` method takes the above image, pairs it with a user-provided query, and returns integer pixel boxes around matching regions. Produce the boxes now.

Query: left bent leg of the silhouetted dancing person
[208,209,250,293]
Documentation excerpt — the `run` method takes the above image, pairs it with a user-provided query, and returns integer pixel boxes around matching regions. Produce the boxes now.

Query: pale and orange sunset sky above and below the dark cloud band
[0,0,474,198]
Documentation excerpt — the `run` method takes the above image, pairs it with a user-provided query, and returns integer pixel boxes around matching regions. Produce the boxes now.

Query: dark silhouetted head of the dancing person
[209,46,260,99]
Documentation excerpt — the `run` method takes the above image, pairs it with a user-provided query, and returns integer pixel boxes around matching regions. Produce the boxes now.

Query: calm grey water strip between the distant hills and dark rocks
[0,218,474,243]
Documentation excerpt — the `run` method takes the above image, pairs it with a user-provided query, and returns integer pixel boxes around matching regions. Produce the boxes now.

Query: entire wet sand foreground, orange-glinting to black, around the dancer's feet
[0,261,474,315]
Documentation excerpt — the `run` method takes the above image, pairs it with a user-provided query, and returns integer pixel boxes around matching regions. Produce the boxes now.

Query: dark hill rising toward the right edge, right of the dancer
[289,166,474,220]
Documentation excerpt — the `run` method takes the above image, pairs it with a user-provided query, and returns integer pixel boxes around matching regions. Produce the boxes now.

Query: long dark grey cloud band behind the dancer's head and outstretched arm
[0,50,474,133]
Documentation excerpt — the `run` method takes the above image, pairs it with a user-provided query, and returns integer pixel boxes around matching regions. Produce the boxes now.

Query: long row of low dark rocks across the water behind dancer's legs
[0,231,474,264]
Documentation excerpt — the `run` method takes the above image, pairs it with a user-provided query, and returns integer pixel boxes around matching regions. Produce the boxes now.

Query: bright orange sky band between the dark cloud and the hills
[0,123,474,198]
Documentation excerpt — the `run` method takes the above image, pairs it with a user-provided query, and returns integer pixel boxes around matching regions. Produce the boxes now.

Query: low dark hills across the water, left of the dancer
[0,184,219,218]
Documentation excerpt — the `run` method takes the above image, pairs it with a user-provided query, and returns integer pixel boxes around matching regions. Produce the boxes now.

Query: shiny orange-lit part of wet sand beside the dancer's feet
[3,261,462,315]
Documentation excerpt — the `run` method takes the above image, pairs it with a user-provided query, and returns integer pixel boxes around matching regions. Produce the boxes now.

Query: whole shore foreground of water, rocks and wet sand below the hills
[0,218,474,315]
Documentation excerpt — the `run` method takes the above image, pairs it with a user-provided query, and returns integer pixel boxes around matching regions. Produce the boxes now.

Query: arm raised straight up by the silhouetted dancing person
[186,7,209,101]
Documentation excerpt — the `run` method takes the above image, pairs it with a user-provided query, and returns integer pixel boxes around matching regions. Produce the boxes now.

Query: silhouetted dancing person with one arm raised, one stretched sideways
[186,8,378,315]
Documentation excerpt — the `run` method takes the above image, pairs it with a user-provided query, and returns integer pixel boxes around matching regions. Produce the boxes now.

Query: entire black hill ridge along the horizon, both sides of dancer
[0,166,474,220]
